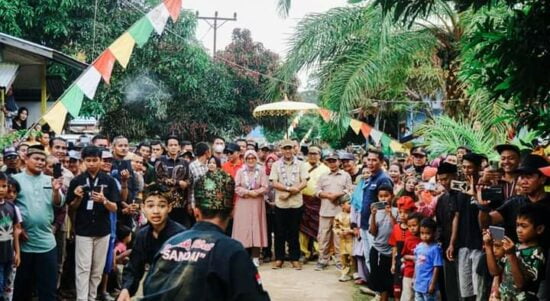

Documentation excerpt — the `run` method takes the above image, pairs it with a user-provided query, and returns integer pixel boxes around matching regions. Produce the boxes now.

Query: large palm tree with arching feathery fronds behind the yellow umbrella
[268,1,470,130]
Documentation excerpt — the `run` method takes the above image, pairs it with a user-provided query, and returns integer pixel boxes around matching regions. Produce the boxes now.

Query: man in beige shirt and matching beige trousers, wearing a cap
[315,154,353,271]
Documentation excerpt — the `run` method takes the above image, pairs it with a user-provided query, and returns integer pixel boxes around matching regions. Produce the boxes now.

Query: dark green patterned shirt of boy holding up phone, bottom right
[499,244,545,301]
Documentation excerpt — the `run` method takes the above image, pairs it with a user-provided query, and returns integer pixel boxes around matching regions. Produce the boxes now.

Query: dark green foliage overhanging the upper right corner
[370,0,550,135]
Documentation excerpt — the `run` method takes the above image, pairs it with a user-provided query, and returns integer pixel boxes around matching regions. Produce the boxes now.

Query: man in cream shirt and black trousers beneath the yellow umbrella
[269,140,308,270]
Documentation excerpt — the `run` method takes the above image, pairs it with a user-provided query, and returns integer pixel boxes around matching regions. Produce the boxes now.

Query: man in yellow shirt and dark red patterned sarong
[300,146,330,262]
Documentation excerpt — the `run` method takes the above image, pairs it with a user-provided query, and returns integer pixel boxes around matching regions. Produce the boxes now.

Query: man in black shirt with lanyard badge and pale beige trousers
[67,146,119,300]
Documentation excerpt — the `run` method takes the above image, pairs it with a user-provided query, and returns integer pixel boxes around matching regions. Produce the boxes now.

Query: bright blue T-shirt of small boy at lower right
[414,242,443,294]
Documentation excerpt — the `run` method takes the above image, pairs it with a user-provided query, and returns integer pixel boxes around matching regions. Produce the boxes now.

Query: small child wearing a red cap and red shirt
[388,196,416,300]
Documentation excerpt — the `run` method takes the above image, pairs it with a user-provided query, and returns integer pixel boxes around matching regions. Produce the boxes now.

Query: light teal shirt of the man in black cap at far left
[13,171,64,253]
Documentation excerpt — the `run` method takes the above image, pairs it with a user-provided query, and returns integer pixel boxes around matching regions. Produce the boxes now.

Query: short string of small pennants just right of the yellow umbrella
[319,109,406,153]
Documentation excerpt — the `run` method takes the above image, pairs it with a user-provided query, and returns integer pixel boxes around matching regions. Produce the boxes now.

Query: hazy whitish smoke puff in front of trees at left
[124,71,172,119]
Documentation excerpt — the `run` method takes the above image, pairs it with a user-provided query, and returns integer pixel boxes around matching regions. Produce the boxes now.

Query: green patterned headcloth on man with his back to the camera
[195,171,235,210]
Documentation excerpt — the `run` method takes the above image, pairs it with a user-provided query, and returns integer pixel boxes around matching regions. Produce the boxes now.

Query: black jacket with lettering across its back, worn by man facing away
[143,222,269,301]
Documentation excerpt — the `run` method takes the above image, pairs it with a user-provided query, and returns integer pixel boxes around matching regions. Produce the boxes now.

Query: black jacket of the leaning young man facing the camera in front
[122,219,185,296]
